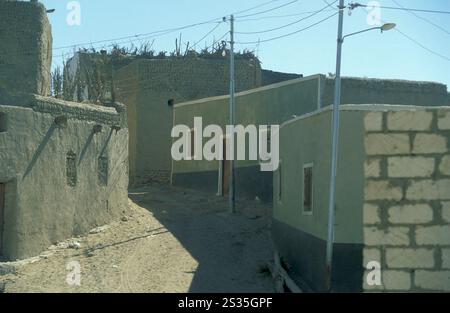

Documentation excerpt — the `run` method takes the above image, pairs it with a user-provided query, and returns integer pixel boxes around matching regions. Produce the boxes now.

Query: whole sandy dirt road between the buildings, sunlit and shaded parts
[0,185,273,293]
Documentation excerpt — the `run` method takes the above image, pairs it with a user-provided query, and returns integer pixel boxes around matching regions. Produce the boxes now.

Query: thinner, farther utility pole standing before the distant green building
[229,15,236,214]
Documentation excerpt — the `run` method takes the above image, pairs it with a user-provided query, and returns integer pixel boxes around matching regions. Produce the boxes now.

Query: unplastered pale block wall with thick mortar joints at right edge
[364,108,450,291]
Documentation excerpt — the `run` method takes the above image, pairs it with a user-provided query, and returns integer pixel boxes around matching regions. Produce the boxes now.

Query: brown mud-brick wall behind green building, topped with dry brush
[115,58,261,185]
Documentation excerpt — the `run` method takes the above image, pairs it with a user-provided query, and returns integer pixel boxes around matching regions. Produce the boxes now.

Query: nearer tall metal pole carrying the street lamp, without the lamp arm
[326,0,345,290]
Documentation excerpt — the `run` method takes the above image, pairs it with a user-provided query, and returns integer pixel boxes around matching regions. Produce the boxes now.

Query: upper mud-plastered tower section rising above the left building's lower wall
[0,1,52,96]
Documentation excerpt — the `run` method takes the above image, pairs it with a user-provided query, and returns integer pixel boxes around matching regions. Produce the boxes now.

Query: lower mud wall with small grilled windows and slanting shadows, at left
[0,95,128,260]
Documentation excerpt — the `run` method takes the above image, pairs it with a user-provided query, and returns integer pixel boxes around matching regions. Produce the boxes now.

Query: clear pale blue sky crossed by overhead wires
[42,0,450,88]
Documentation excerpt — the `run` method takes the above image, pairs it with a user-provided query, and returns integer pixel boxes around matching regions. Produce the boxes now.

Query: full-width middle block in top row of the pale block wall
[387,110,433,131]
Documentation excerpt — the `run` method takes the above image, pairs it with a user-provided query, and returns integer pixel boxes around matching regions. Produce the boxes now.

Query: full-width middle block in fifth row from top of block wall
[389,204,433,224]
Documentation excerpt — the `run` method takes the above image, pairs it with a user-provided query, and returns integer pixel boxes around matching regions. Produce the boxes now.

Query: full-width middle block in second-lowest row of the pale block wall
[386,248,435,269]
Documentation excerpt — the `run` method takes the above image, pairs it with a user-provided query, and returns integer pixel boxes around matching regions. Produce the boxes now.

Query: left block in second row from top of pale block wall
[365,134,411,155]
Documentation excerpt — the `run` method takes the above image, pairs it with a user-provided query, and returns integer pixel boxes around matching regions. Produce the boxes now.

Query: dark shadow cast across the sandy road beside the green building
[129,185,273,293]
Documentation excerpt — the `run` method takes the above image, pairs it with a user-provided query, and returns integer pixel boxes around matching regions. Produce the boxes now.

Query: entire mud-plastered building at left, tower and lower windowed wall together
[0,1,128,260]
